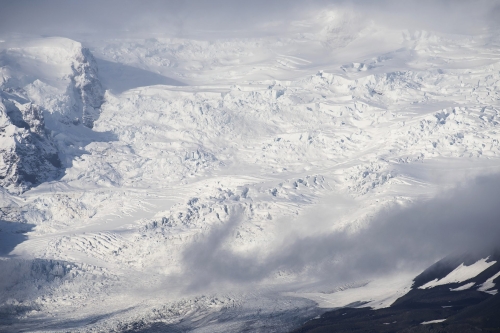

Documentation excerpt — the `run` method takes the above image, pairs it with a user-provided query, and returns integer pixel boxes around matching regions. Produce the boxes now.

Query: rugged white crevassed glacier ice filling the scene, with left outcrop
[0,9,500,332]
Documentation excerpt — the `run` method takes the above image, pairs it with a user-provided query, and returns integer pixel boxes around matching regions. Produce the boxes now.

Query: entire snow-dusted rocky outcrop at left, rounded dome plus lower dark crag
[0,38,104,193]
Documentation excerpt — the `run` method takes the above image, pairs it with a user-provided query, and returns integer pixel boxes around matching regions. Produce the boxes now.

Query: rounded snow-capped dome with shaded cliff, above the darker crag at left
[0,38,104,128]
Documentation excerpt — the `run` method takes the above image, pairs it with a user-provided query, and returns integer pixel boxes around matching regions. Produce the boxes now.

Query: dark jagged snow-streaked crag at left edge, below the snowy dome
[0,89,61,193]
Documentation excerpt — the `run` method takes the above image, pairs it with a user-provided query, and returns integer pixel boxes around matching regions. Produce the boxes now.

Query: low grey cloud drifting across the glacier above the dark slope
[184,175,500,289]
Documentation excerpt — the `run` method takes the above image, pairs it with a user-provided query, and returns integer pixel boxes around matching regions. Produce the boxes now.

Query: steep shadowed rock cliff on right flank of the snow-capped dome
[71,48,104,128]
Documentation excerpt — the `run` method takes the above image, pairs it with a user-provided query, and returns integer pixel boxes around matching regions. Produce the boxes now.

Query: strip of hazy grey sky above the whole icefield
[0,0,500,37]
